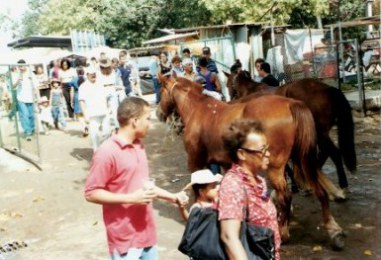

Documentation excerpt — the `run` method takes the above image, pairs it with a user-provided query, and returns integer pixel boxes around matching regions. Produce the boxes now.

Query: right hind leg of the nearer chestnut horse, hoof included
[312,171,345,250]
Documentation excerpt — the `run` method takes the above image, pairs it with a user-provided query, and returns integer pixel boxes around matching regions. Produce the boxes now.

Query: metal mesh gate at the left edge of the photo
[0,64,41,166]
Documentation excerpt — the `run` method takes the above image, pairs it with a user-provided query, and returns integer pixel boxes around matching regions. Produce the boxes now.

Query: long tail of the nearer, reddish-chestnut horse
[290,101,324,193]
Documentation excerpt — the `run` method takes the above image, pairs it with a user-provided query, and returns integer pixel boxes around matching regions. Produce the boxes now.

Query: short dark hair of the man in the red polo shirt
[118,97,149,127]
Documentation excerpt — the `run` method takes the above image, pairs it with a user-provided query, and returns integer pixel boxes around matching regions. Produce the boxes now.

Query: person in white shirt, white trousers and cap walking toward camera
[78,68,111,152]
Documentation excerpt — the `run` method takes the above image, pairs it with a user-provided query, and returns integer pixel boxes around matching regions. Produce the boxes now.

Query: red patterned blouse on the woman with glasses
[218,164,281,259]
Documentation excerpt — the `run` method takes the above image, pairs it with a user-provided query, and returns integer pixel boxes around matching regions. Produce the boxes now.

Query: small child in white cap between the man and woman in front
[180,169,222,221]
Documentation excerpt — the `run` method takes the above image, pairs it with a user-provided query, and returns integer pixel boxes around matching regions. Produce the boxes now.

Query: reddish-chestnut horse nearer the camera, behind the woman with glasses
[157,78,344,249]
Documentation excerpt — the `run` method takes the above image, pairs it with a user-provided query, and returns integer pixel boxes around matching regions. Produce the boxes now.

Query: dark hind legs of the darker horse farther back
[318,135,348,189]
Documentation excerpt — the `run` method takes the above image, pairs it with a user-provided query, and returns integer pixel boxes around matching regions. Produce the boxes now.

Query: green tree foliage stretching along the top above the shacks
[20,0,374,48]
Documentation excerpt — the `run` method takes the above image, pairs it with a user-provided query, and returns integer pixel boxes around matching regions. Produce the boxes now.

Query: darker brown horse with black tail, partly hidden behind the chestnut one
[225,71,357,188]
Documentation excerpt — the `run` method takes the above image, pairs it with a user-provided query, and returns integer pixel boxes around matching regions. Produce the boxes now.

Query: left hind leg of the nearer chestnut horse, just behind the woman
[268,167,292,243]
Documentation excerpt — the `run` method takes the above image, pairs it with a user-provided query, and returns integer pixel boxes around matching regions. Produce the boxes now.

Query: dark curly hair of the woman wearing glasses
[222,119,264,163]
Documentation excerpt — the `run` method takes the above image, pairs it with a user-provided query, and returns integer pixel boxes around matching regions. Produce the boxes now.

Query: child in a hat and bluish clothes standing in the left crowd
[50,78,66,130]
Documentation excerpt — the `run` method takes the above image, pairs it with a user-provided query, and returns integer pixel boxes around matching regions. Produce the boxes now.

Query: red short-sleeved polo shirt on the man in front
[85,136,157,255]
